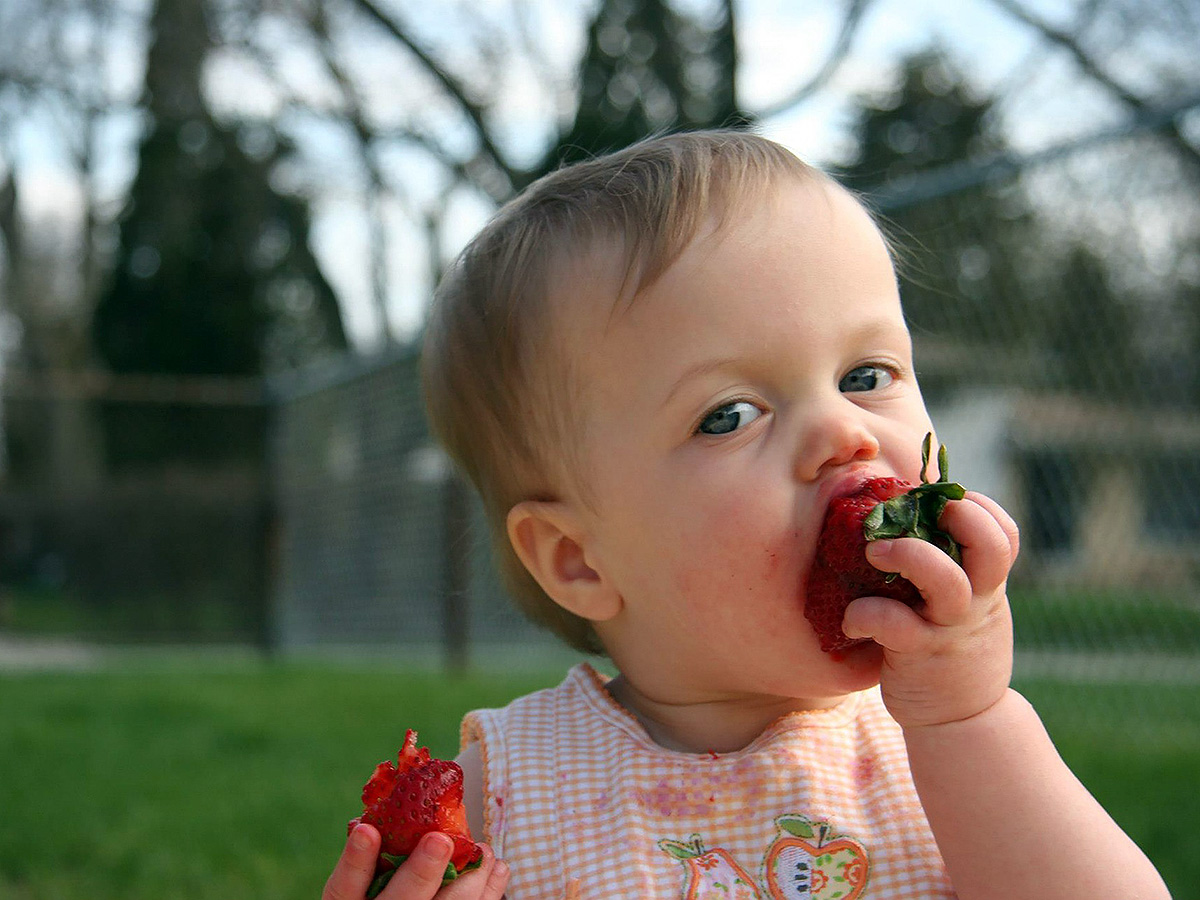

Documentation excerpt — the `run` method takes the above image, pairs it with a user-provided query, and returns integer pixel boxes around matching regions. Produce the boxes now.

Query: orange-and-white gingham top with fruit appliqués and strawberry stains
[462,664,954,900]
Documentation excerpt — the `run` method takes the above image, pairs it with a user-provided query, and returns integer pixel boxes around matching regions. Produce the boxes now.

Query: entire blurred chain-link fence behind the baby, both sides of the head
[0,102,1200,679]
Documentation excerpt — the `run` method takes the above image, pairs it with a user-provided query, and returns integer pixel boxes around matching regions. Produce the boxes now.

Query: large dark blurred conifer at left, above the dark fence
[92,0,347,466]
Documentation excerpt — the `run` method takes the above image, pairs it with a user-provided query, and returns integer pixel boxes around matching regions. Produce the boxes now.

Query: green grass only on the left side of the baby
[0,665,561,900]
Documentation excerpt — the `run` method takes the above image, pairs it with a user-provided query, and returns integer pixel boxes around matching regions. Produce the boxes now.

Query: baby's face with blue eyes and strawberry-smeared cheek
[556,181,931,704]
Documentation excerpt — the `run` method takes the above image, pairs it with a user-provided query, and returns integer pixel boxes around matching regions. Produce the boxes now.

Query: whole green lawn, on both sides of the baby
[0,662,1200,900]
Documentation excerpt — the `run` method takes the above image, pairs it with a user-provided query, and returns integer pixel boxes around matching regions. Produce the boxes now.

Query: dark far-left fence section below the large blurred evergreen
[0,372,272,643]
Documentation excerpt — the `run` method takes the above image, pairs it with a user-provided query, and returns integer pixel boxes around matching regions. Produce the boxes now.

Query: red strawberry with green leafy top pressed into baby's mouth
[804,434,966,652]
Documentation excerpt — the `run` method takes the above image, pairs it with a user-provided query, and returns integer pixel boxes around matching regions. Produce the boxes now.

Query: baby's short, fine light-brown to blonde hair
[421,131,826,653]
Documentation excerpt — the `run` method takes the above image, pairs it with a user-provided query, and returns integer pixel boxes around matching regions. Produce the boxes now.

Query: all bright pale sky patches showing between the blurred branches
[9,0,1190,348]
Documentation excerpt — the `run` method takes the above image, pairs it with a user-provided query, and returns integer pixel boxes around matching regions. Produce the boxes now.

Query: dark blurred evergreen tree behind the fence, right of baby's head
[838,48,1032,389]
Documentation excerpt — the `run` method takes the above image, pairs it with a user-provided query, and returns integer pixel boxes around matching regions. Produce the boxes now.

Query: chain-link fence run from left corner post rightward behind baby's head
[275,103,1200,676]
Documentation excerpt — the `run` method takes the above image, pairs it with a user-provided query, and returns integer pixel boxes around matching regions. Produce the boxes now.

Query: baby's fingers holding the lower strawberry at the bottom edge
[320,824,509,900]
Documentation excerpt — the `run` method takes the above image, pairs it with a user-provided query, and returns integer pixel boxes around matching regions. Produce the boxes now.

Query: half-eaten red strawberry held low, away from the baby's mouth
[348,728,482,898]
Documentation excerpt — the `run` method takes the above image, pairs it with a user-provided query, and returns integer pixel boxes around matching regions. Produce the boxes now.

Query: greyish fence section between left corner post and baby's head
[266,348,556,665]
